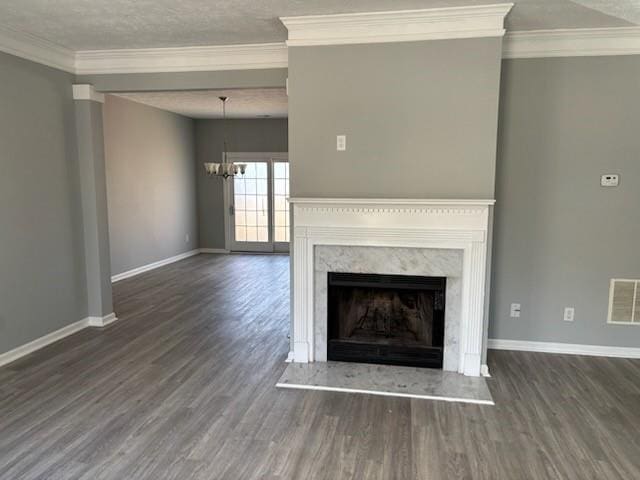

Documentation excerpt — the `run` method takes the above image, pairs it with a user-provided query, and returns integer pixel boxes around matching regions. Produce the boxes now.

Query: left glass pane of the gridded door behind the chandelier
[232,162,270,251]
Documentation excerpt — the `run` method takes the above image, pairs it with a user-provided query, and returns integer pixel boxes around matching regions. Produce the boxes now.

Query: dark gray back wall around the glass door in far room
[196,119,288,248]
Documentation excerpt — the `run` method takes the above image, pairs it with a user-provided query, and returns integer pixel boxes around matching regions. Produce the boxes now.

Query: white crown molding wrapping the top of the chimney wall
[280,3,513,47]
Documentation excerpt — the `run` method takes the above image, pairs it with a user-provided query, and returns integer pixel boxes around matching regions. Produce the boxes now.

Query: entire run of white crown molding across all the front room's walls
[0,23,640,75]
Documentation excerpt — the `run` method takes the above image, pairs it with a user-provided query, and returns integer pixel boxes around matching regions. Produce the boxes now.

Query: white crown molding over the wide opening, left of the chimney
[75,43,288,75]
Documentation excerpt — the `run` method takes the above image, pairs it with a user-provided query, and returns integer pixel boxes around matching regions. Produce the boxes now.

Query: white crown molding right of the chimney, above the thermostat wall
[502,27,640,58]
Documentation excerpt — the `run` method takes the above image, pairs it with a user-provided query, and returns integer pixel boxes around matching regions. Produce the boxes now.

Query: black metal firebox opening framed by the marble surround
[327,272,446,368]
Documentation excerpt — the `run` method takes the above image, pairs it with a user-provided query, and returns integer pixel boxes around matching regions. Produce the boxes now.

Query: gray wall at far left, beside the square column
[0,53,87,353]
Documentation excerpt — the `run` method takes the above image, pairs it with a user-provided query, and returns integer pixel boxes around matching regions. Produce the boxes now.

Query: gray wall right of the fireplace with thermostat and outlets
[490,56,640,347]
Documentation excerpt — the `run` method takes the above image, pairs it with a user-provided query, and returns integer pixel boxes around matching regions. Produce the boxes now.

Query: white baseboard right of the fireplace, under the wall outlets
[488,338,640,358]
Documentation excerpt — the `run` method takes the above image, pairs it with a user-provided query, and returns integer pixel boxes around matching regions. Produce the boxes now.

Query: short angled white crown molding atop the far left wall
[0,27,75,73]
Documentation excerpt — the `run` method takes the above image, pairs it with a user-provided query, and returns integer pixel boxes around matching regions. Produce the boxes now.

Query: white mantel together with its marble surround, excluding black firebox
[289,198,494,376]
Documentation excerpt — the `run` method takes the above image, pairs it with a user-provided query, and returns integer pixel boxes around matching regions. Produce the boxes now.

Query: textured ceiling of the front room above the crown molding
[0,0,640,50]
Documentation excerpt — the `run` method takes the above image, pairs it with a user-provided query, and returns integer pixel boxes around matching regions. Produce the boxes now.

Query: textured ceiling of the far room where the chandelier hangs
[117,88,287,118]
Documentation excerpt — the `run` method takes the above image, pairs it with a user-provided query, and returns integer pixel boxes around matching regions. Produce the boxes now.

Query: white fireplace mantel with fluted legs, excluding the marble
[289,198,495,376]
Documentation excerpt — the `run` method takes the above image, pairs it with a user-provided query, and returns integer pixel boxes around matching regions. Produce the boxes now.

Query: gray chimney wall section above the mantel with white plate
[289,38,501,198]
